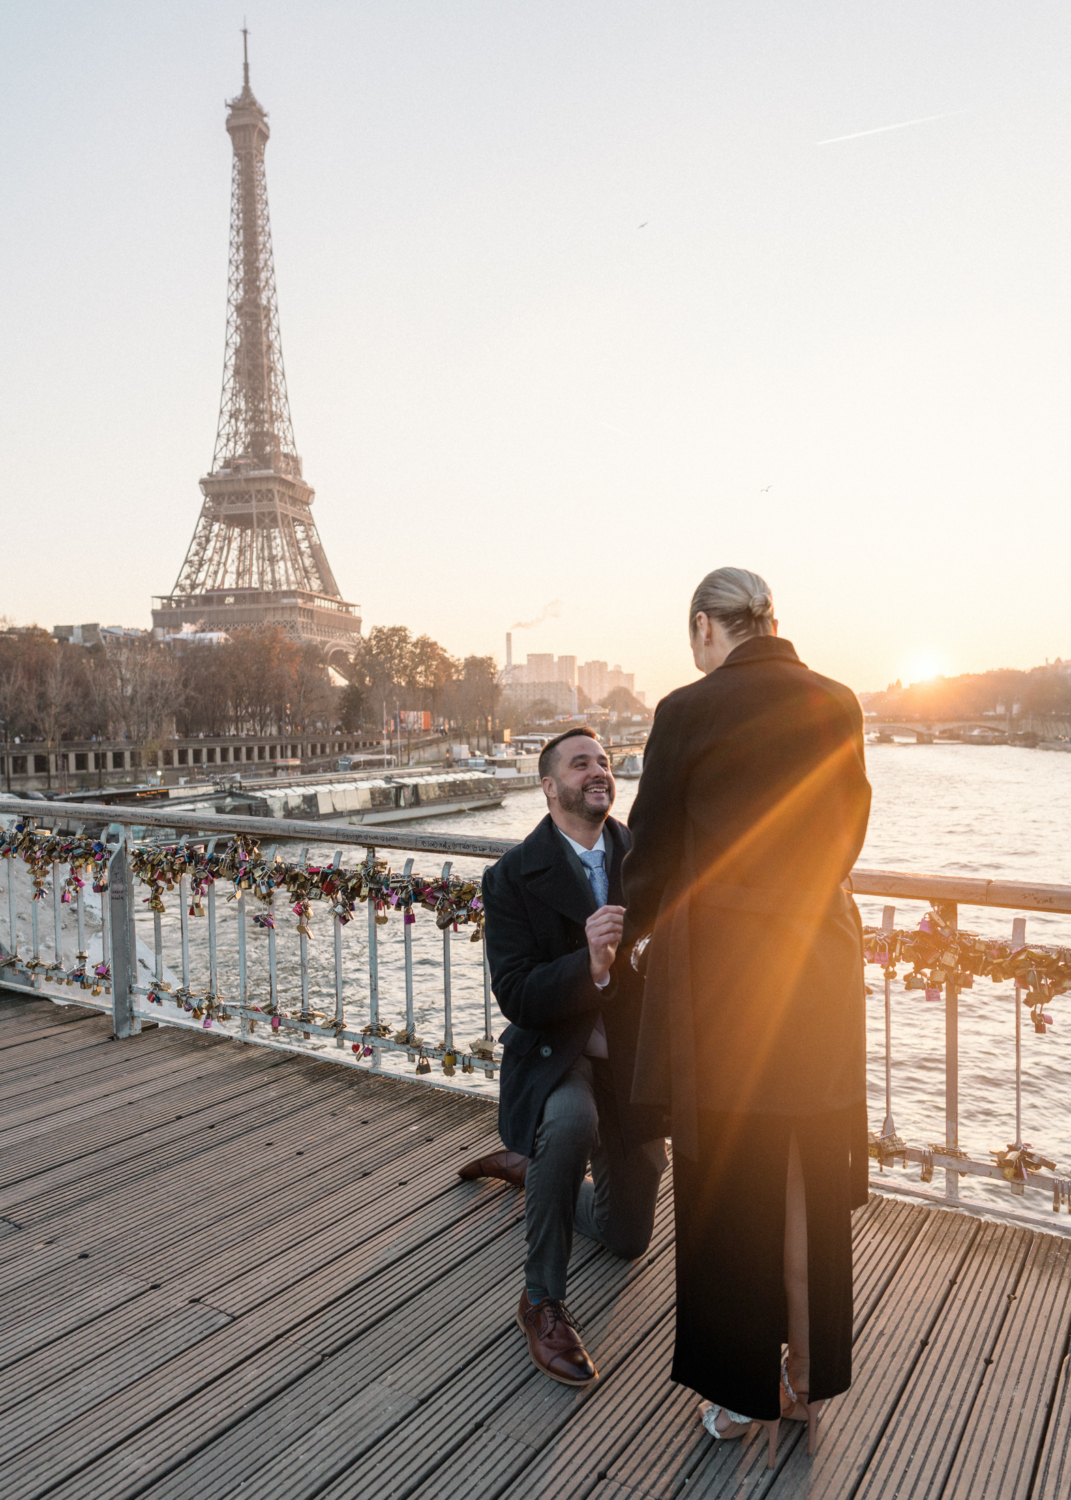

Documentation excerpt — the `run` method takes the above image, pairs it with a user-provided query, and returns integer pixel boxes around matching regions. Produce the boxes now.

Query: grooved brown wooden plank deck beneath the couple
[0,992,1071,1500]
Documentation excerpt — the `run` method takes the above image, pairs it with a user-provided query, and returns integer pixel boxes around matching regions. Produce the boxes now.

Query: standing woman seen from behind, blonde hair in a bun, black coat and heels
[624,567,870,1467]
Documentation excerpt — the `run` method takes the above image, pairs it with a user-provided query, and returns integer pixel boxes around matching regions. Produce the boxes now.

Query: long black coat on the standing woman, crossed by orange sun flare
[624,636,870,1155]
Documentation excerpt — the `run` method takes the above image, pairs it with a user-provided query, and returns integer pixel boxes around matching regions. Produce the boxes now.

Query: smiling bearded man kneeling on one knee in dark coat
[462,729,666,1386]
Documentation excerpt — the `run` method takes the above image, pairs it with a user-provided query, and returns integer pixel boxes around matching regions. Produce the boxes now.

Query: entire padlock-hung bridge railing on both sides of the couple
[0,797,1071,1214]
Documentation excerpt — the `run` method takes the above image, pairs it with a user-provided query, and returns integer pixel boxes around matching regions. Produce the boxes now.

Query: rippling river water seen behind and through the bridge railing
[10,744,1071,1221]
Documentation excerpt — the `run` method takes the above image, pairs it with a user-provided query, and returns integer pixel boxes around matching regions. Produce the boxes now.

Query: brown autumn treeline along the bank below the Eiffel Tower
[0,626,497,749]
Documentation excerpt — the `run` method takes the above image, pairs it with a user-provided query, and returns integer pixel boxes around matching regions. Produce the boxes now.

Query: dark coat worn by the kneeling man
[483,815,662,1157]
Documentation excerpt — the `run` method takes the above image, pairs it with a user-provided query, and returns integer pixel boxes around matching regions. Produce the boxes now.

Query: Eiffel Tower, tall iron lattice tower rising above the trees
[153,30,360,657]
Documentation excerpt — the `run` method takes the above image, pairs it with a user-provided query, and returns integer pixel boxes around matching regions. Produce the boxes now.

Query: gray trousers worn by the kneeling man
[525,1056,668,1301]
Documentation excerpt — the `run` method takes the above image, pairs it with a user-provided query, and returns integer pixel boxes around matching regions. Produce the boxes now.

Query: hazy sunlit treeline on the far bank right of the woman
[863,660,1071,723]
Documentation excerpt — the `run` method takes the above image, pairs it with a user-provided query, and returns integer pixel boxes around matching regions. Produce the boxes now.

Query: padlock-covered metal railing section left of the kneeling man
[0,798,510,1077]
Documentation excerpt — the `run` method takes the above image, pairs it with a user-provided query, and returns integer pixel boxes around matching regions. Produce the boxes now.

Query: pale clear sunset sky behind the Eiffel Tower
[0,0,1071,702]
